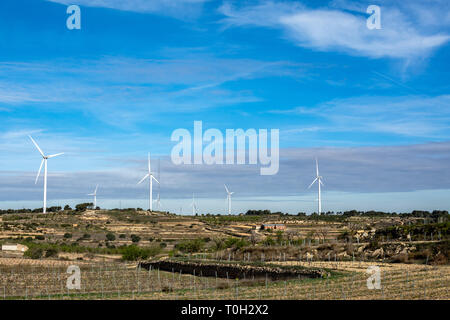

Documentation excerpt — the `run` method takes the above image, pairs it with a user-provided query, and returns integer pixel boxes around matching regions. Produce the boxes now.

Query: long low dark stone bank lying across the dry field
[139,260,326,280]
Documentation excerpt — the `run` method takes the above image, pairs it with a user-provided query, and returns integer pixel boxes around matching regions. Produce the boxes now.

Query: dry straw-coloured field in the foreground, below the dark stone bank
[0,261,450,300]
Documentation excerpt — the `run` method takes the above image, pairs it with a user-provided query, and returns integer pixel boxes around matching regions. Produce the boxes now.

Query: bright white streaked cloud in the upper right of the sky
[219,1,450,59]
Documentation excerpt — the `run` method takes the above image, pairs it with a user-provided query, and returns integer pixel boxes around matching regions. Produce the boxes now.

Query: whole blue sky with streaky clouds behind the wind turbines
[0,0,450,212]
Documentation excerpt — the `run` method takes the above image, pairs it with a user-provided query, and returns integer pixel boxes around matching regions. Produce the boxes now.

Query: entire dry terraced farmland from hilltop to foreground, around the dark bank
[0,210,450,300]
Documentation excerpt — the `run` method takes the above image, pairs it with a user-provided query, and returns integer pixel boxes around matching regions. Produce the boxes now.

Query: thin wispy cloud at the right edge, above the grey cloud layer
[270,95,450,141]
